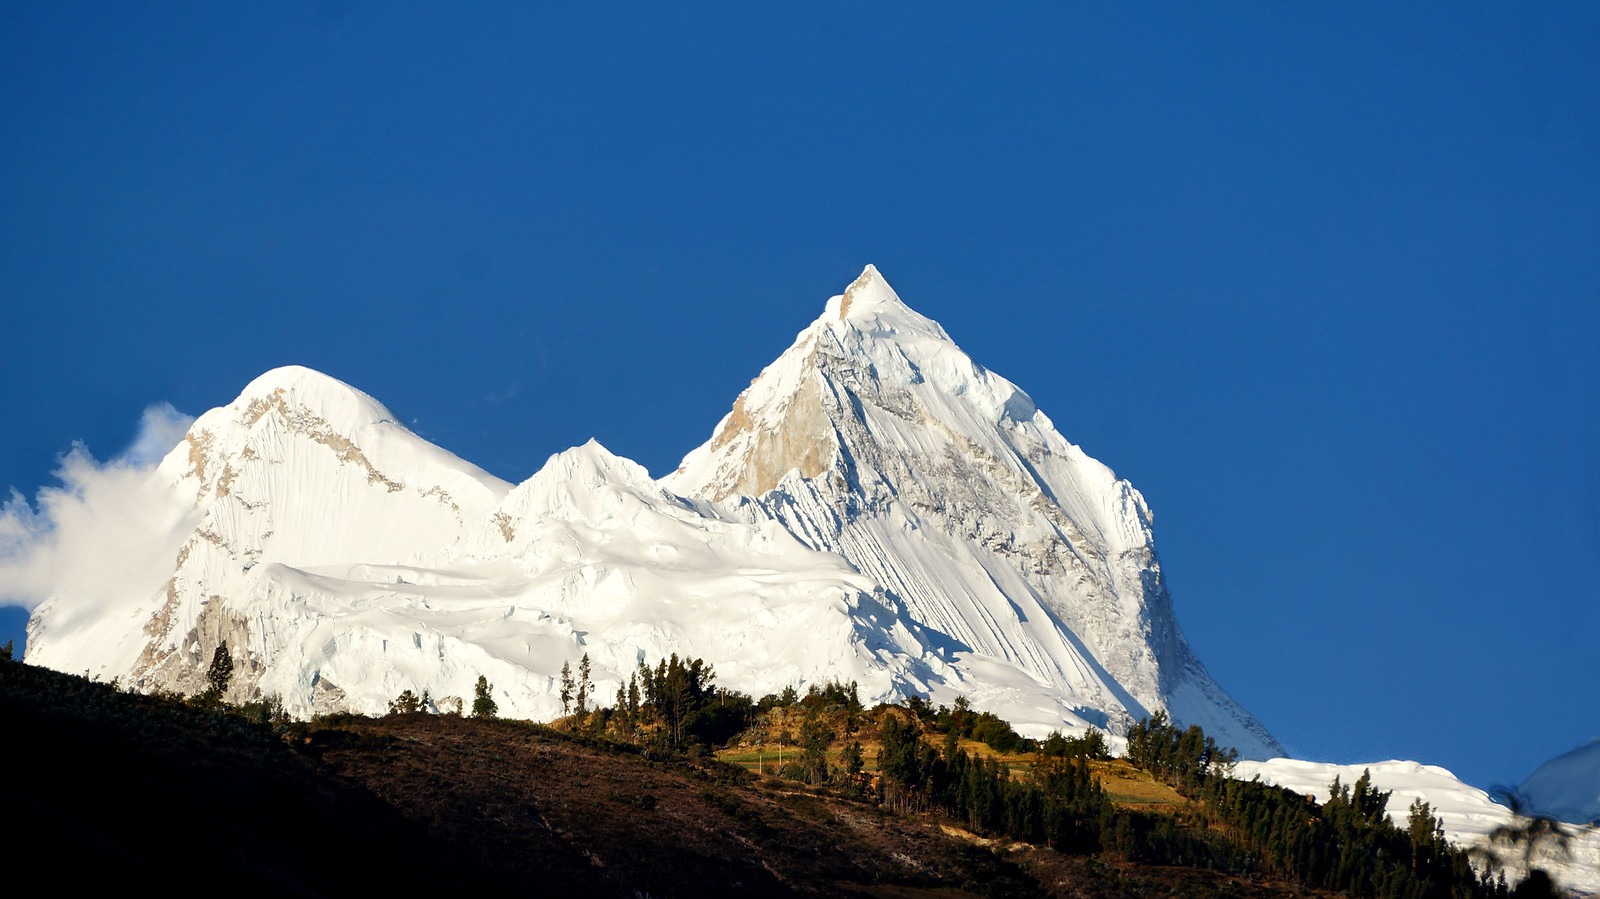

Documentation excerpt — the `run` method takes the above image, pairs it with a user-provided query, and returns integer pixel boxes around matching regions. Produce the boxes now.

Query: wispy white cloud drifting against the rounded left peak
[0,403,194,617]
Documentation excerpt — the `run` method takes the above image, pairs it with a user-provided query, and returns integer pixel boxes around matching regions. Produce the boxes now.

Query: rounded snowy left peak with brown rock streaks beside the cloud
[29,359,510,689]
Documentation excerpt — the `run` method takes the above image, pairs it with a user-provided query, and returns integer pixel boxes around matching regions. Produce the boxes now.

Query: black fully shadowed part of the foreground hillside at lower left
[0,661,508,896]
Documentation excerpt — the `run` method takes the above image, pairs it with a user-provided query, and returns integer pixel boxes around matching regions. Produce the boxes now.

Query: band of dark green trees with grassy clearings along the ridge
[387,654,1561,899]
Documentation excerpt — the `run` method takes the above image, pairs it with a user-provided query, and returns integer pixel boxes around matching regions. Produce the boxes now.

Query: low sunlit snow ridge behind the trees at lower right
[1234,758,1600,896]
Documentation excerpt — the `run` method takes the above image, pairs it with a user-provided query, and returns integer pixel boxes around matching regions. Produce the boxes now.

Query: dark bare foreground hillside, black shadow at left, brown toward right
[9,661,1363,897]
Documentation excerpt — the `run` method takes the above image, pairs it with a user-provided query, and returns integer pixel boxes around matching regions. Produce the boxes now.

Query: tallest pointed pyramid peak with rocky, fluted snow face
[662,266,1282,757]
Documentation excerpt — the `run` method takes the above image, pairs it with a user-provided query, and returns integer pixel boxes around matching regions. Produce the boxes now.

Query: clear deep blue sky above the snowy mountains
[0,2,1600,784]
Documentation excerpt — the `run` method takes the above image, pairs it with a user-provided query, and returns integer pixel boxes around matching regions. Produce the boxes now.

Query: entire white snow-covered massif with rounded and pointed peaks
[27,267,1278,757]
